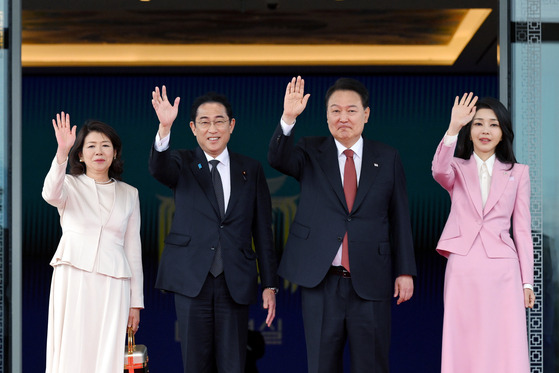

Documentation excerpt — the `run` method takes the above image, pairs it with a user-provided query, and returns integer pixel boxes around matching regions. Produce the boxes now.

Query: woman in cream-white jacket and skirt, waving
[42,112,144,373]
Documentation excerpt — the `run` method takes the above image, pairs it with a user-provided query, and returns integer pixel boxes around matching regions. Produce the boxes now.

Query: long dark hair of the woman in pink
[454,97,517,168]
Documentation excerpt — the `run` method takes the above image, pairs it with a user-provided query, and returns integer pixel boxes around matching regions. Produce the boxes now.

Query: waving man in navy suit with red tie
[268,77,416,373]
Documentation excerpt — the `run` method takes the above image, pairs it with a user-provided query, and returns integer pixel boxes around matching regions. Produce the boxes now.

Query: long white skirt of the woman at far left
[46,264,130,373]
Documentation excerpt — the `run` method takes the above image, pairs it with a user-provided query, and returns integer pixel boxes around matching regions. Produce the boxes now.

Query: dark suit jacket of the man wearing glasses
[149,147,277,304]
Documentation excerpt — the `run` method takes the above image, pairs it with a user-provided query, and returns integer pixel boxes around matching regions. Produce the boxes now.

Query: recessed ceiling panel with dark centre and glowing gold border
[22,9,491,67]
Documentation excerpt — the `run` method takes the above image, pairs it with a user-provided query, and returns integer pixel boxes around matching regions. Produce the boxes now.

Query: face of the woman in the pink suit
[470,109,503,161]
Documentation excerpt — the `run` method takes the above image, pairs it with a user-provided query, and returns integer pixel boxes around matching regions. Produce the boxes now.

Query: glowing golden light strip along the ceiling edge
[22,9,491,67]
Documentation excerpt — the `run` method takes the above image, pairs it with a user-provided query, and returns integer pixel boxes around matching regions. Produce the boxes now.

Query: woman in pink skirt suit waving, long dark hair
[432,93,535,373]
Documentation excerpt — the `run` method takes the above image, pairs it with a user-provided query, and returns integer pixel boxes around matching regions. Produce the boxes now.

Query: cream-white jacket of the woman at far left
[42,157,144,308]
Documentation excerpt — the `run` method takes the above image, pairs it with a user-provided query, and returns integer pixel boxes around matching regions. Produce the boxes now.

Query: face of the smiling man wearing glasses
[190,102,235,158]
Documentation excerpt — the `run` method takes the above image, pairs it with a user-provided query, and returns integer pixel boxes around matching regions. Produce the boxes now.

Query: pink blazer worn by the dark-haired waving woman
[432,141,534,284]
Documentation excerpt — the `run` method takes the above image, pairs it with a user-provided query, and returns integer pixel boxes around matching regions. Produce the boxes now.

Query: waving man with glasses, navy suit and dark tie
[149,86,278,373]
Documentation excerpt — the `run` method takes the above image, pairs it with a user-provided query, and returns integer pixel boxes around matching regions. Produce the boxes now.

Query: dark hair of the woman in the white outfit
[68,120,124,180]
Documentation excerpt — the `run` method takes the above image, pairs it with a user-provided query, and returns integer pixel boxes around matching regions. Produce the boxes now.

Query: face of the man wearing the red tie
[326,91,370,148]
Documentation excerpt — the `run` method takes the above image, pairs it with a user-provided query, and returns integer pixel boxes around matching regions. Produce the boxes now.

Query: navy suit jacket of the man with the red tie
[268,126,416,300]
